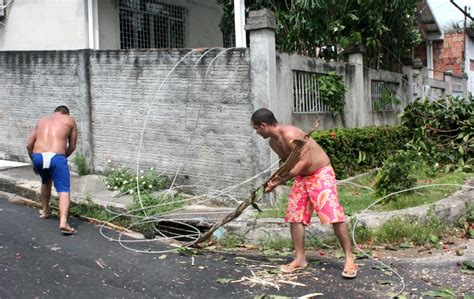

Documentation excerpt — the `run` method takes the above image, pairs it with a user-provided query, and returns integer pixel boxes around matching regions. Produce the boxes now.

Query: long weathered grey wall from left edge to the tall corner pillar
[0,49,259,202]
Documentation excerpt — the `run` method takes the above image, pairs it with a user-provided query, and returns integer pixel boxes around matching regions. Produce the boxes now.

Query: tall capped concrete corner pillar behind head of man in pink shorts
[245,9,280,202]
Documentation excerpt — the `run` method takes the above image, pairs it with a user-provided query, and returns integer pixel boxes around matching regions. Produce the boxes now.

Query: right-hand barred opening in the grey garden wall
[370,80,400,111]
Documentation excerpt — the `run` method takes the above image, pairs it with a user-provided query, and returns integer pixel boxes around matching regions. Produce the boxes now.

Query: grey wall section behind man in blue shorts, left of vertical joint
[0,51,90,161]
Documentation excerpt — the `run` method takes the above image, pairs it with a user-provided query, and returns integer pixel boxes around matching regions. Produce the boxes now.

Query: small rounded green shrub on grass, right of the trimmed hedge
[375,151,418,196]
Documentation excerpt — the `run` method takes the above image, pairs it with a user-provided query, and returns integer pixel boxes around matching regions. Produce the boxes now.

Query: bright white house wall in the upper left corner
[0,0,88,50]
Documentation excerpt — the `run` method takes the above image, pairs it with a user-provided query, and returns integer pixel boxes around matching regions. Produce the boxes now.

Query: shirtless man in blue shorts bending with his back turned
[26,106,77,235]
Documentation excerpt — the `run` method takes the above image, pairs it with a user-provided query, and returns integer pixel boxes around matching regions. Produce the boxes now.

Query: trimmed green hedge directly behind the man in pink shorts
[312,126,409,179]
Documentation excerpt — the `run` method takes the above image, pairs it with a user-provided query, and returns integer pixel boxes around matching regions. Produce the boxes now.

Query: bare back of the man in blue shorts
[28,112,77,157]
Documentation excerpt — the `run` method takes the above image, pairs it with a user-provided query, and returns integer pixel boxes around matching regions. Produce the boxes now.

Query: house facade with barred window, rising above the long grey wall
[0,0,229,51]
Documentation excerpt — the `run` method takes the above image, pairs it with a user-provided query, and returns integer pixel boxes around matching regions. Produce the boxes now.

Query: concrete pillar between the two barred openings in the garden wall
[345,45,372,127]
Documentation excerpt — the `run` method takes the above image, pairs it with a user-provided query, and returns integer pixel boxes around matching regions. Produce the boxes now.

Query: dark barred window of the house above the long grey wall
[119,0,186,49]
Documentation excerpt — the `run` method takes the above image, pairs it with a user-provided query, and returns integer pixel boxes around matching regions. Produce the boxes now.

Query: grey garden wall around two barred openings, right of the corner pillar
[274,53,411,131]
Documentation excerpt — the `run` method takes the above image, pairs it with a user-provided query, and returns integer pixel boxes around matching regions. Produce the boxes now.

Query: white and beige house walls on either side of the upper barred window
[0,0,223,50]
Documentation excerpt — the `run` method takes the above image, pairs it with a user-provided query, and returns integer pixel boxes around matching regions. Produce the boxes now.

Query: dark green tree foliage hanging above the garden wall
[217,0,421,69]
